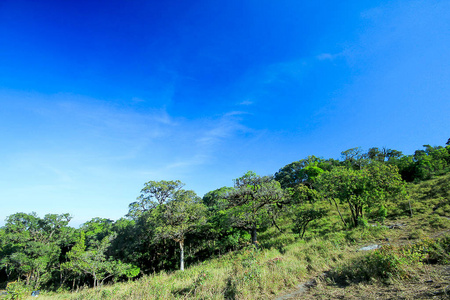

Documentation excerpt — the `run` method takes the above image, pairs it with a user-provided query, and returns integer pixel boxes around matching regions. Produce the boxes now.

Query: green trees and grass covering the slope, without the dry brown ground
[0,140,450,299]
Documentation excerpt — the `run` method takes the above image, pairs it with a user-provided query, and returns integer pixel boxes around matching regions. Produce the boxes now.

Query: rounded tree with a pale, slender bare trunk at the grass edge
[128,180,206,271]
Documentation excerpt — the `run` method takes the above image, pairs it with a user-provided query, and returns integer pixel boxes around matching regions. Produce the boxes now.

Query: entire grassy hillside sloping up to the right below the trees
[29,174,450,299]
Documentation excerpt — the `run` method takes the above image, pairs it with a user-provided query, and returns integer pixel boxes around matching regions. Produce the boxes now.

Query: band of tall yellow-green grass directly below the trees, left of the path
[37,228,386,299]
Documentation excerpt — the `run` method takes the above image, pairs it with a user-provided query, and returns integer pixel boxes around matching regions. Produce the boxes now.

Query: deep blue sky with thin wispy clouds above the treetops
[0,0,450,226]
